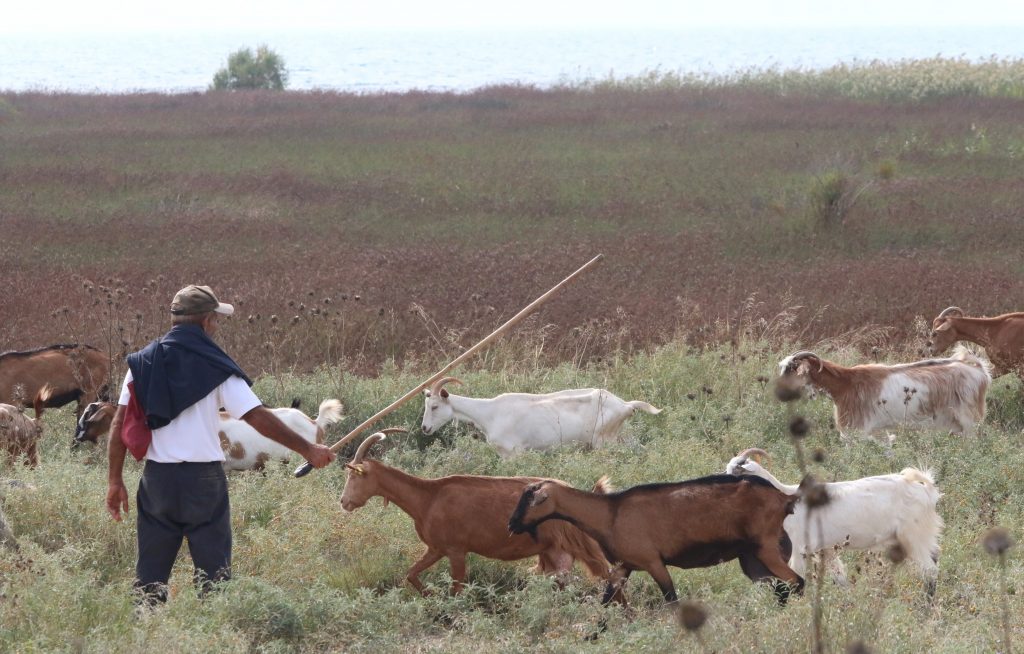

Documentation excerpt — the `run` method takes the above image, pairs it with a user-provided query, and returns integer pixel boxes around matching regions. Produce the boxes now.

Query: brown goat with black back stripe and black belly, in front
[508,475,804,602]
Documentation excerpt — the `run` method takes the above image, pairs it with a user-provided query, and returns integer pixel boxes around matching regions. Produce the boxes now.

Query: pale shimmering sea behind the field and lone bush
[0,27,1024,93]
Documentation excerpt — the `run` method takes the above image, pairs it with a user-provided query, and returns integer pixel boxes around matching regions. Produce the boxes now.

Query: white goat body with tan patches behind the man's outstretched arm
[220,399,342,470]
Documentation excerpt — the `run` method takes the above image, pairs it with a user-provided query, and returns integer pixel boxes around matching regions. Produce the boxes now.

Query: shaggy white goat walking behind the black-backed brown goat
[725,448,942,595]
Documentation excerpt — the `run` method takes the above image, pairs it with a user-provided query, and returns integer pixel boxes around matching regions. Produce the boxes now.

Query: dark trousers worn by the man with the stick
[135,461,231,602]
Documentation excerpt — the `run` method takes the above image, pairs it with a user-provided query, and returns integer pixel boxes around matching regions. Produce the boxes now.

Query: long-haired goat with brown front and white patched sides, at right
[778,347,992,438]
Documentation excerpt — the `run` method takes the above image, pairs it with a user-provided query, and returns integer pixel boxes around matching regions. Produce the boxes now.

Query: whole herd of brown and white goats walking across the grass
[0,307,1024,614]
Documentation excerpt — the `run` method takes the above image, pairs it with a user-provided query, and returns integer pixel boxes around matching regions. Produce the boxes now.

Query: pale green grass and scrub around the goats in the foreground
[0,340,1024,653]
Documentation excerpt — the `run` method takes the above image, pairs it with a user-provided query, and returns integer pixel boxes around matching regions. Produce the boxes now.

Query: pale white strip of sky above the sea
[6,0,1024,36]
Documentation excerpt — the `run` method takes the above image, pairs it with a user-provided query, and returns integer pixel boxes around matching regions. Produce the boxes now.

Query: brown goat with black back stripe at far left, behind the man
[0,344,111,418]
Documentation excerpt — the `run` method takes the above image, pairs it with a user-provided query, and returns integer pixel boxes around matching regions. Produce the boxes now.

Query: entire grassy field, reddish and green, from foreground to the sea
[0,60,1024,654]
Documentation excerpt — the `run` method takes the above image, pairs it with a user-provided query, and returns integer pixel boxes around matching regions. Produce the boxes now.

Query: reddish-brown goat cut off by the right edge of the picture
[927,307,1024,379]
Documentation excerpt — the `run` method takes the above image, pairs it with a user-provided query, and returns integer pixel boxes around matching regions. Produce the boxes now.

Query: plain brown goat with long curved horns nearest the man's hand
[341,430,621,599]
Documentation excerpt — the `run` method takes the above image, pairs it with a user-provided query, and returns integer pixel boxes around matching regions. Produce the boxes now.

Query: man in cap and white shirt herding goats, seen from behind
[106,285,335,604]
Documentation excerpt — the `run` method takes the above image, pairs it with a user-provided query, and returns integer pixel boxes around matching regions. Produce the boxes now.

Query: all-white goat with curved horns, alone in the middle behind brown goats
[423,377,662,455]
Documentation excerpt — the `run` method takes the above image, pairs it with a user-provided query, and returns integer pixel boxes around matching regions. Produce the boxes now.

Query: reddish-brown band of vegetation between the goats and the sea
[0,87,1024,372]
